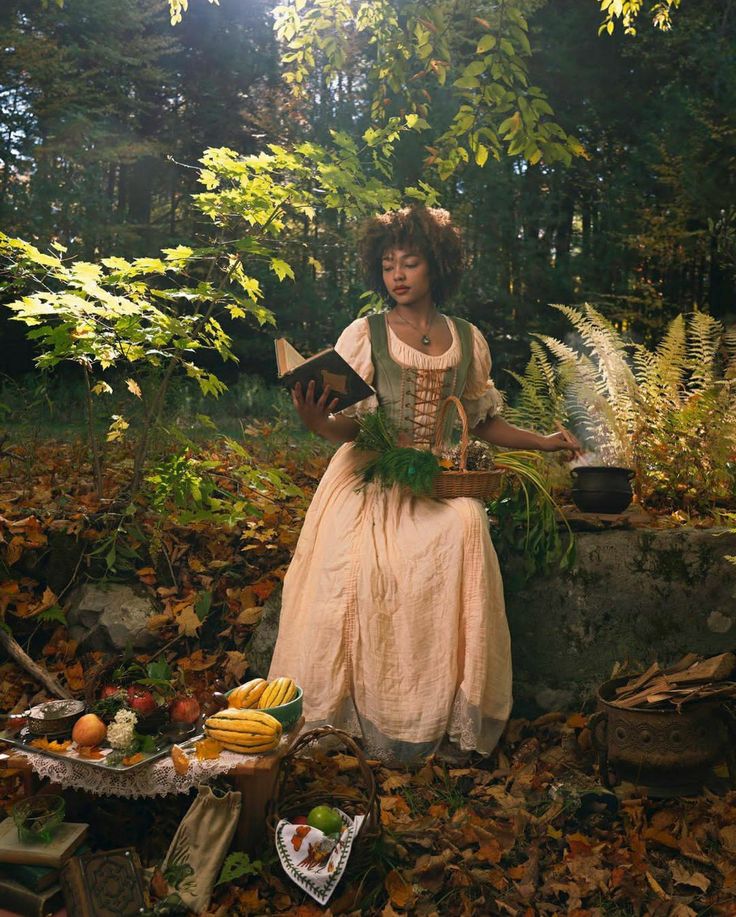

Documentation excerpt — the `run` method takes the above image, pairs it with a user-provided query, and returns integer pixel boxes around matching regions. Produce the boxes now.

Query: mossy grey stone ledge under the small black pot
[507,528,736,716]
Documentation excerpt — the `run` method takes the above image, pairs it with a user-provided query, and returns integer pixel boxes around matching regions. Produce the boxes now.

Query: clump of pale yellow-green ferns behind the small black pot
[535,306,736,512]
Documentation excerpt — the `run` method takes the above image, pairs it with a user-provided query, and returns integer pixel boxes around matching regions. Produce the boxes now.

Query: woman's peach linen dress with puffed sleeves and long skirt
[269,318,511,761]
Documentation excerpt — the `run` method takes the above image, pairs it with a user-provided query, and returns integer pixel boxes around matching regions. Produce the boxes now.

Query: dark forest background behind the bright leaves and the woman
[0,0,736,384]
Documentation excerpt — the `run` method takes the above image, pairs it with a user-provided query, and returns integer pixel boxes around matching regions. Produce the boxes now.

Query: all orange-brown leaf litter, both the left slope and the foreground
[0,431,736,917]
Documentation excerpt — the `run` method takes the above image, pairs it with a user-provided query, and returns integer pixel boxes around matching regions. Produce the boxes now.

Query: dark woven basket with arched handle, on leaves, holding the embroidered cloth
[266,726,382,875]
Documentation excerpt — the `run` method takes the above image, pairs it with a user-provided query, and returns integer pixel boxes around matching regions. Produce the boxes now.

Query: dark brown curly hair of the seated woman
[358,205,463,306]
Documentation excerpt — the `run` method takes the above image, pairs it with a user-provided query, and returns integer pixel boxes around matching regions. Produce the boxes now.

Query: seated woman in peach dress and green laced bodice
[269,207,579,761]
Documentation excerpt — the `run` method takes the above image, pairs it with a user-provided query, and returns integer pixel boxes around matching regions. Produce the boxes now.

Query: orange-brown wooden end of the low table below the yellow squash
[225,717,304,854]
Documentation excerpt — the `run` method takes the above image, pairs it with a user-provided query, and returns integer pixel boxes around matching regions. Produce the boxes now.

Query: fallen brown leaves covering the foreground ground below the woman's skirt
[198,713,736,917]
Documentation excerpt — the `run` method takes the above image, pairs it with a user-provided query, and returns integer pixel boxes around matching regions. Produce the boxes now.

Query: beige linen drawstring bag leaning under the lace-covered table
[161,784,241,914]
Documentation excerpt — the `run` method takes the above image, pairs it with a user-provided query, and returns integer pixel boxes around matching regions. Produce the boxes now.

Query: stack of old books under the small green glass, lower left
[0,818,88,917]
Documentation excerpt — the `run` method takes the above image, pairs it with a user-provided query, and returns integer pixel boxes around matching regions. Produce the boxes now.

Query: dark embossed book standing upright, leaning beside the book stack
[61,847,146,917]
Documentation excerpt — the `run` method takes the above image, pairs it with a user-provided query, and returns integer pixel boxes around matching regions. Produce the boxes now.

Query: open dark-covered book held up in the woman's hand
[274,338,375,411]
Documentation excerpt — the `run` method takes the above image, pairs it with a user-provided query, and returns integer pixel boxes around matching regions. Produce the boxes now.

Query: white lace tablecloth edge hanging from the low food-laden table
[14,737,286,799]
